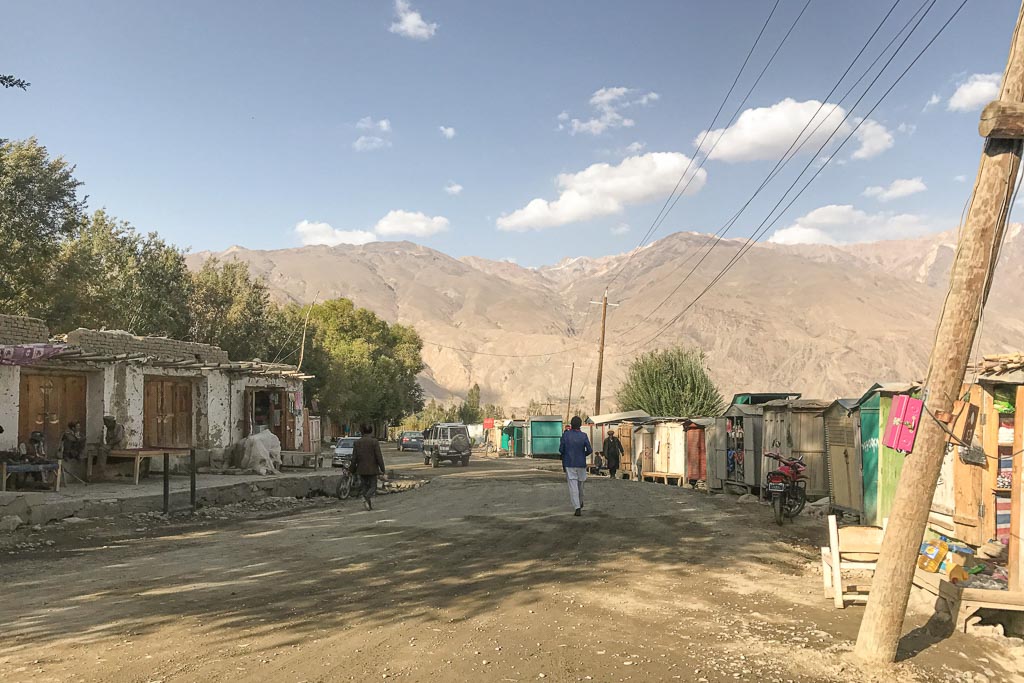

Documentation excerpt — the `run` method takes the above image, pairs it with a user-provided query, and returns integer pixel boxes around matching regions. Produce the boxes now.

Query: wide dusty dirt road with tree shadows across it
[0,455,1024,683]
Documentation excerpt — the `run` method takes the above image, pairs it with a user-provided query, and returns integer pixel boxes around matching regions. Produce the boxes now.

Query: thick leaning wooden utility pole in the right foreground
[851,4,1024,663]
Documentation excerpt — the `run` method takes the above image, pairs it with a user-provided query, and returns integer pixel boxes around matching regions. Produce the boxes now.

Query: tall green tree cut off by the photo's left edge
[0,137,85,317]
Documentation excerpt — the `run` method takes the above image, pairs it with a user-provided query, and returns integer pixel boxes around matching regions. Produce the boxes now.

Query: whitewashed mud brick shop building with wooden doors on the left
[0,315,309,465]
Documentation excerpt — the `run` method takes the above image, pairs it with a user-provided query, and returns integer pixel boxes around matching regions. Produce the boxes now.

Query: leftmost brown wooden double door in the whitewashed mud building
[17,373,86,458]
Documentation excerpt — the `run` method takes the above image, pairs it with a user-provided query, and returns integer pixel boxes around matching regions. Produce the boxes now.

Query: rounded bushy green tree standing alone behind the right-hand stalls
[618,347,725,418]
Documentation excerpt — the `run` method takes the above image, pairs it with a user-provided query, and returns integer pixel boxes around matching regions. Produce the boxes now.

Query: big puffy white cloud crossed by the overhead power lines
[693,97,893,162]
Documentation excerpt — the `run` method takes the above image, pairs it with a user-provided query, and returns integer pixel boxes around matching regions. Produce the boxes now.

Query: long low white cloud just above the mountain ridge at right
[769,204,929,245]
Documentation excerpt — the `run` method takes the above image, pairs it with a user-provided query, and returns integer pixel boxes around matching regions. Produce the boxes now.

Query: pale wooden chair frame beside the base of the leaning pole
[821,515,889,609]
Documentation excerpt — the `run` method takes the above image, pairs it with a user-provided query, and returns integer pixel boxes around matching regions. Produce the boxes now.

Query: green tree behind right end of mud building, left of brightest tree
[188,259,274,360]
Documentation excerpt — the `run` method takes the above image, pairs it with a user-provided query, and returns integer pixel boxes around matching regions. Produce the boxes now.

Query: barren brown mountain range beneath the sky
[189,224,1024,413]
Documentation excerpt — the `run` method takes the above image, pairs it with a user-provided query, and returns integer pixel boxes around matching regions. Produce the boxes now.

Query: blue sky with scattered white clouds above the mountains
[0,0,1019,265]
